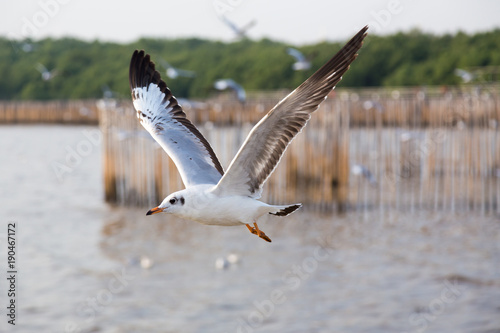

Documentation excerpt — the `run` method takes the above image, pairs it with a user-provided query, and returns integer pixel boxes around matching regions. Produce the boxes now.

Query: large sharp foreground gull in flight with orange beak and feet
[129,27,368,242]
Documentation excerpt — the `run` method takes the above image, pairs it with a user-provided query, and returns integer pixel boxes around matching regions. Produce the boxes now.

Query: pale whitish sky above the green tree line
[0,0,500,45]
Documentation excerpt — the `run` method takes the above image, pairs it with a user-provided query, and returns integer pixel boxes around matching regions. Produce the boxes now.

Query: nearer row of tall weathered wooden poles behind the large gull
[100,88,500,213]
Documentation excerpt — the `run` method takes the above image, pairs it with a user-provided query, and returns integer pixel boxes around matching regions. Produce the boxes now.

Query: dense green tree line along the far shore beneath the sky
[0,29,500,100]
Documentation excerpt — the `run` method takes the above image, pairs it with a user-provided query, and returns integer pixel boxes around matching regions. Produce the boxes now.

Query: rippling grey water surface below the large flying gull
[0,126,500,332]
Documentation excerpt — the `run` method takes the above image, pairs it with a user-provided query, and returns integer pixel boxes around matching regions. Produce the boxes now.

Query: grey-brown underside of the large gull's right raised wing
[214,27,368,198]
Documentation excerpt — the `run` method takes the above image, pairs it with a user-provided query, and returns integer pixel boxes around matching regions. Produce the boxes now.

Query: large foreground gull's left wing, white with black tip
[129,50,224,187]
